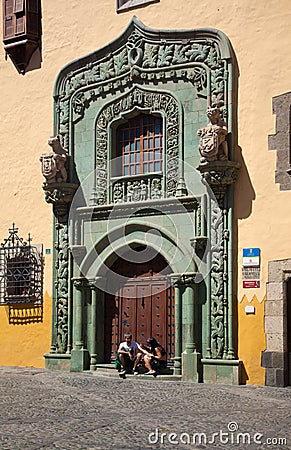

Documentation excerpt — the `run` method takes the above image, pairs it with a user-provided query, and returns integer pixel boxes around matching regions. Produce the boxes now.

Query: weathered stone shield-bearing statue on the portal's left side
[40,136,68,183]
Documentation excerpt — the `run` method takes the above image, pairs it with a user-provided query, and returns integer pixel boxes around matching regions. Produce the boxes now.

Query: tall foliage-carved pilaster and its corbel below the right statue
[194,161,240,359]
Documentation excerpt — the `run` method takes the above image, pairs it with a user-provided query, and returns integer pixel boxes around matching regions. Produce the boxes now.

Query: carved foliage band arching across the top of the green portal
[56,25,227,153]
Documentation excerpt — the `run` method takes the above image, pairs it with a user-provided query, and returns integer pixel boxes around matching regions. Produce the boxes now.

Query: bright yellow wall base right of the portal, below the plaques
[238,295,266,385]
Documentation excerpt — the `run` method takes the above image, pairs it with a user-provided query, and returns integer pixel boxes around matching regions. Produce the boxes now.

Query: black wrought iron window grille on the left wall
[0,223,43,305]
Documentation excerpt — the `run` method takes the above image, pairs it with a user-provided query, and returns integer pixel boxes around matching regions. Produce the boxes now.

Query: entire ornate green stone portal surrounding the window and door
[44,18,240,383]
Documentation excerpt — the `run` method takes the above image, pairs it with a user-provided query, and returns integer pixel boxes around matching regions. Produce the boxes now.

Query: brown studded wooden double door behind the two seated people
[105,276,175,363]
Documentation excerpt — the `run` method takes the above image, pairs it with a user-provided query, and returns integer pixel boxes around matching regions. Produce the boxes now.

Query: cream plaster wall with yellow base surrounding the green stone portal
[0,0,291,383]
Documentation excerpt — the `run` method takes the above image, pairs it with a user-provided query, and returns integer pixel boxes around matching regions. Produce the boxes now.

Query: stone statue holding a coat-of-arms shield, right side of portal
[197,107,228,164]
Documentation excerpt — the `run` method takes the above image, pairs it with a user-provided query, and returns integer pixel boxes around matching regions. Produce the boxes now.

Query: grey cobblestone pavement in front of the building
[0,367,291,450]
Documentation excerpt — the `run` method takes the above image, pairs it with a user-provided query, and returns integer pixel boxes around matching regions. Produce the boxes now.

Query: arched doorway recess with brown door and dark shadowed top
[104,246,175,363]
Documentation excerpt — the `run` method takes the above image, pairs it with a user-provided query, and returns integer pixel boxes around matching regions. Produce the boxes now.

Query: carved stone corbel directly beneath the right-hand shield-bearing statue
[197,161,240,204]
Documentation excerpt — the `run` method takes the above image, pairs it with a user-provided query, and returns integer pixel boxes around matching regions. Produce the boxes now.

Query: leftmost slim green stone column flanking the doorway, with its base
[70,277,89,372]
